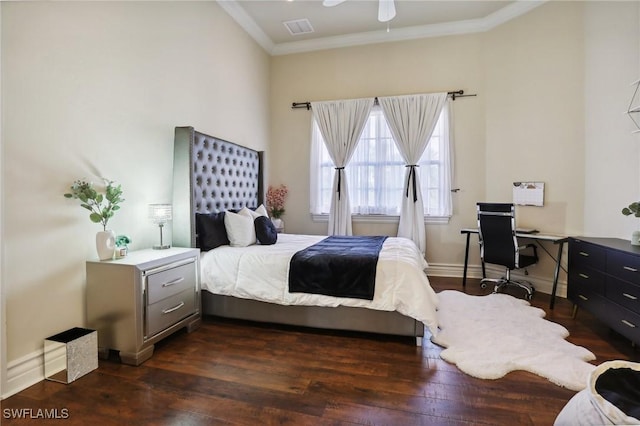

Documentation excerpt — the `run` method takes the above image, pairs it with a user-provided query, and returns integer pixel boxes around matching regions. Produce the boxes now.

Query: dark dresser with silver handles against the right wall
[567,237,640,343]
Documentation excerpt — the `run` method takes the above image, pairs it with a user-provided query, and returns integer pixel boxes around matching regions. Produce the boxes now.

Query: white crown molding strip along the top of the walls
[217,0,548,56]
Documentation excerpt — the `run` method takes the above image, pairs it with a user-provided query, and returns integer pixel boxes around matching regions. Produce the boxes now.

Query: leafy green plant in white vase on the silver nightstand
[64,179,124,260]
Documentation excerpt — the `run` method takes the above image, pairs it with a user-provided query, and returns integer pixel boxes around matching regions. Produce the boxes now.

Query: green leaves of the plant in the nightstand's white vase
[64,179,124,231]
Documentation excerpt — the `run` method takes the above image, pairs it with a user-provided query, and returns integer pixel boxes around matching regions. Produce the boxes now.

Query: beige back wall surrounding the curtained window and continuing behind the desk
[270,2,584,278]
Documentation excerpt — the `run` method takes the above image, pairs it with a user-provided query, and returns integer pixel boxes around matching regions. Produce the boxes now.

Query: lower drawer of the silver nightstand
[146,288,196,337]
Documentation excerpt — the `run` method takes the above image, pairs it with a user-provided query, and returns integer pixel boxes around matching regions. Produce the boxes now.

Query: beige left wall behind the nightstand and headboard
[1,2,269,380]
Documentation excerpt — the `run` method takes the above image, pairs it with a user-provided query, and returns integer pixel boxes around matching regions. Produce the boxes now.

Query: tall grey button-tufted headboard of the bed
[173,127,264,247]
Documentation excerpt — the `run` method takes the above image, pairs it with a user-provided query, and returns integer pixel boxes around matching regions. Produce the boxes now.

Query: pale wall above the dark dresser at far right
[583,2,640,240]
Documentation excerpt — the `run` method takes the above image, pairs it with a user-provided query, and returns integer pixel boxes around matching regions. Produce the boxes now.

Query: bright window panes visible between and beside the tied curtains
[310,105,451,217]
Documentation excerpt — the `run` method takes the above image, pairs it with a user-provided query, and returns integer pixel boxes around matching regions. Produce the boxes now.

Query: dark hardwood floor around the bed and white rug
[1,277,638,426]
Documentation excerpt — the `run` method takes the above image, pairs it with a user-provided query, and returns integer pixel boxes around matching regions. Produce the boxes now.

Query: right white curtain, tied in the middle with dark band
[378,93,447,253]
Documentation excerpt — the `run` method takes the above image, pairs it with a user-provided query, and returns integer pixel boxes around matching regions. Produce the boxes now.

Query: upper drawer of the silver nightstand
[147,260,196,305]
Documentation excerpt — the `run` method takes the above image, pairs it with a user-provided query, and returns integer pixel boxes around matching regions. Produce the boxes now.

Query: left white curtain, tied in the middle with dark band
[311,98,374,235]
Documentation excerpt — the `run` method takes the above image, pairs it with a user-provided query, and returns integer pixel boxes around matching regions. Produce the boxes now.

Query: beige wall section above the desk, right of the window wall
[484,2,584,234]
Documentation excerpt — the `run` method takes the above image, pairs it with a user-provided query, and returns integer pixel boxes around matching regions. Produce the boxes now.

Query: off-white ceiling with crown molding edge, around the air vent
[217,0,544,55]
